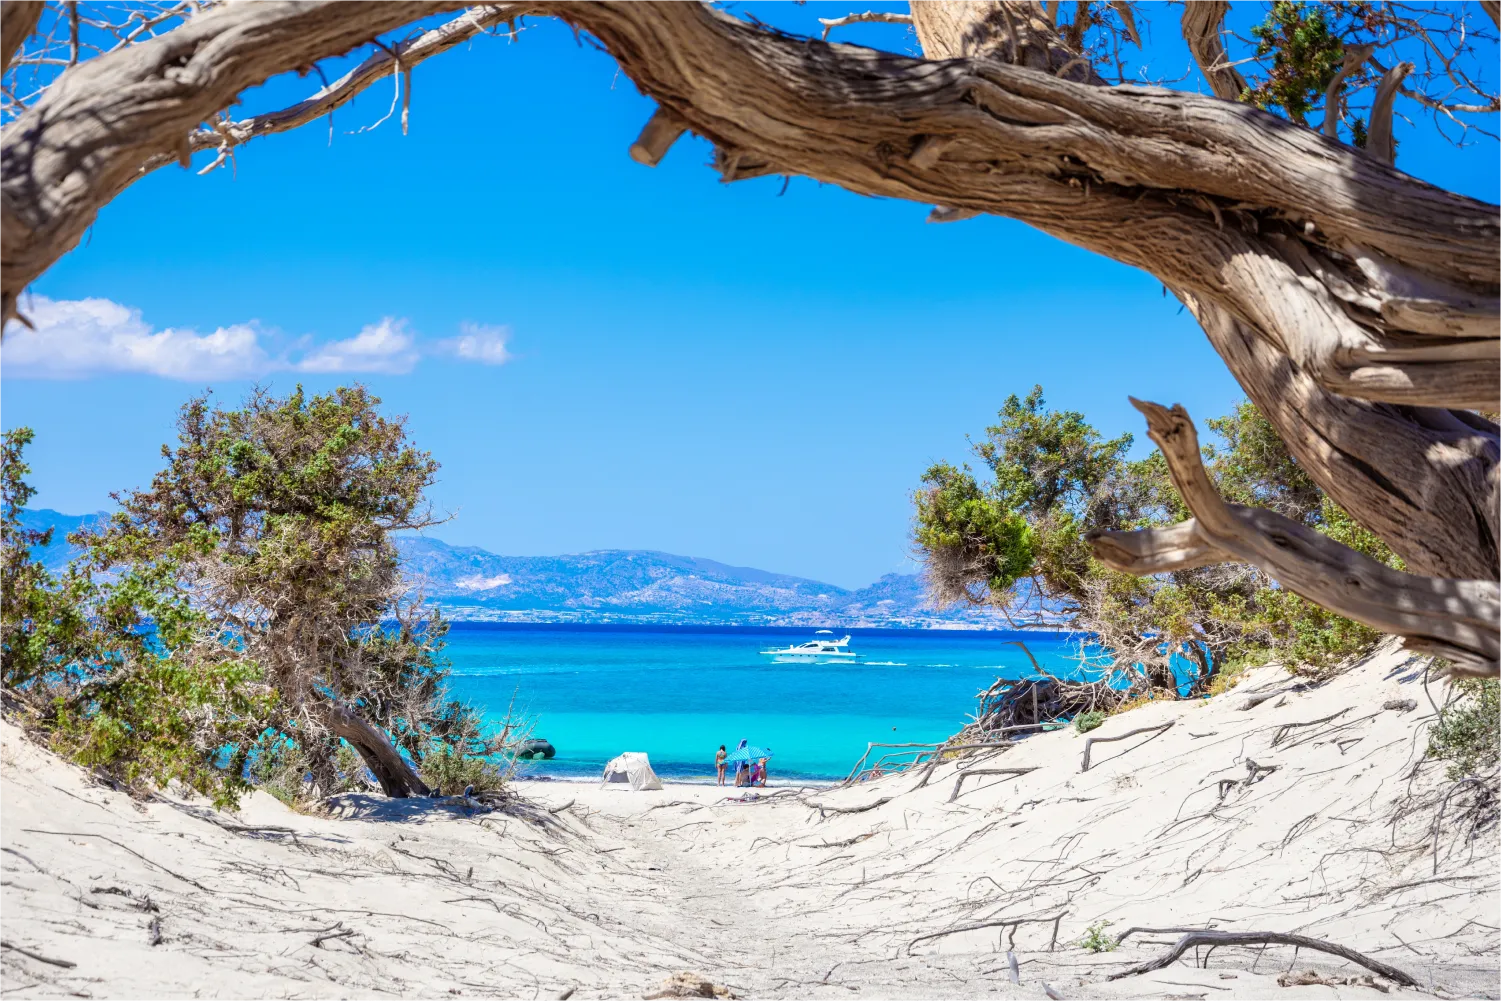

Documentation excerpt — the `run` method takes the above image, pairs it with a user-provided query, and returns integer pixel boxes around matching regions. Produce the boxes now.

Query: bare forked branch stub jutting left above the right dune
[1091,399,1501,675]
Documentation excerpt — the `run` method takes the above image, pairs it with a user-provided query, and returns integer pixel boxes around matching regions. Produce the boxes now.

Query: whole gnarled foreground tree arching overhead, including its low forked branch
[0,0,1501,672]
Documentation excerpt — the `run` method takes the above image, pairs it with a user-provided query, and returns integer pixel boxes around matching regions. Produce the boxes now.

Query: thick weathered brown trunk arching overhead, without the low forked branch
[0,0,1501,578]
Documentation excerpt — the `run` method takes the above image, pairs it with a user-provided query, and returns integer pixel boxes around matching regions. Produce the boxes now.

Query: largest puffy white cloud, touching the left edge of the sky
[0,296,272,380]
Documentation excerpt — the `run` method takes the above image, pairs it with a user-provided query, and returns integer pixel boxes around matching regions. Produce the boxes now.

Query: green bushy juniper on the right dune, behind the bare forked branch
[914,387,1396,698]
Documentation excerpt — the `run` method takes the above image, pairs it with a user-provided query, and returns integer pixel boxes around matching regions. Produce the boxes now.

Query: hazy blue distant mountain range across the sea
[23,510,1032,629]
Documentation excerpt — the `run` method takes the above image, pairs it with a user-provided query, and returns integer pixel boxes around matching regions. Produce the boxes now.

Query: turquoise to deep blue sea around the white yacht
[449,623,1079,783]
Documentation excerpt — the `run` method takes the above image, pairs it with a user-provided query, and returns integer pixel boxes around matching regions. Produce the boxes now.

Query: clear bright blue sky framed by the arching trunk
[0,2,1501,587]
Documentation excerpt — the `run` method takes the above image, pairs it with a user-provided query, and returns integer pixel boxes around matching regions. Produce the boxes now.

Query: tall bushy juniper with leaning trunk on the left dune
[75,386,495,795]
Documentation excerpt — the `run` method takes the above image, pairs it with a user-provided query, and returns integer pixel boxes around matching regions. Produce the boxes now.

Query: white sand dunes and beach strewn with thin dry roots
[0,651,1501,1001]
